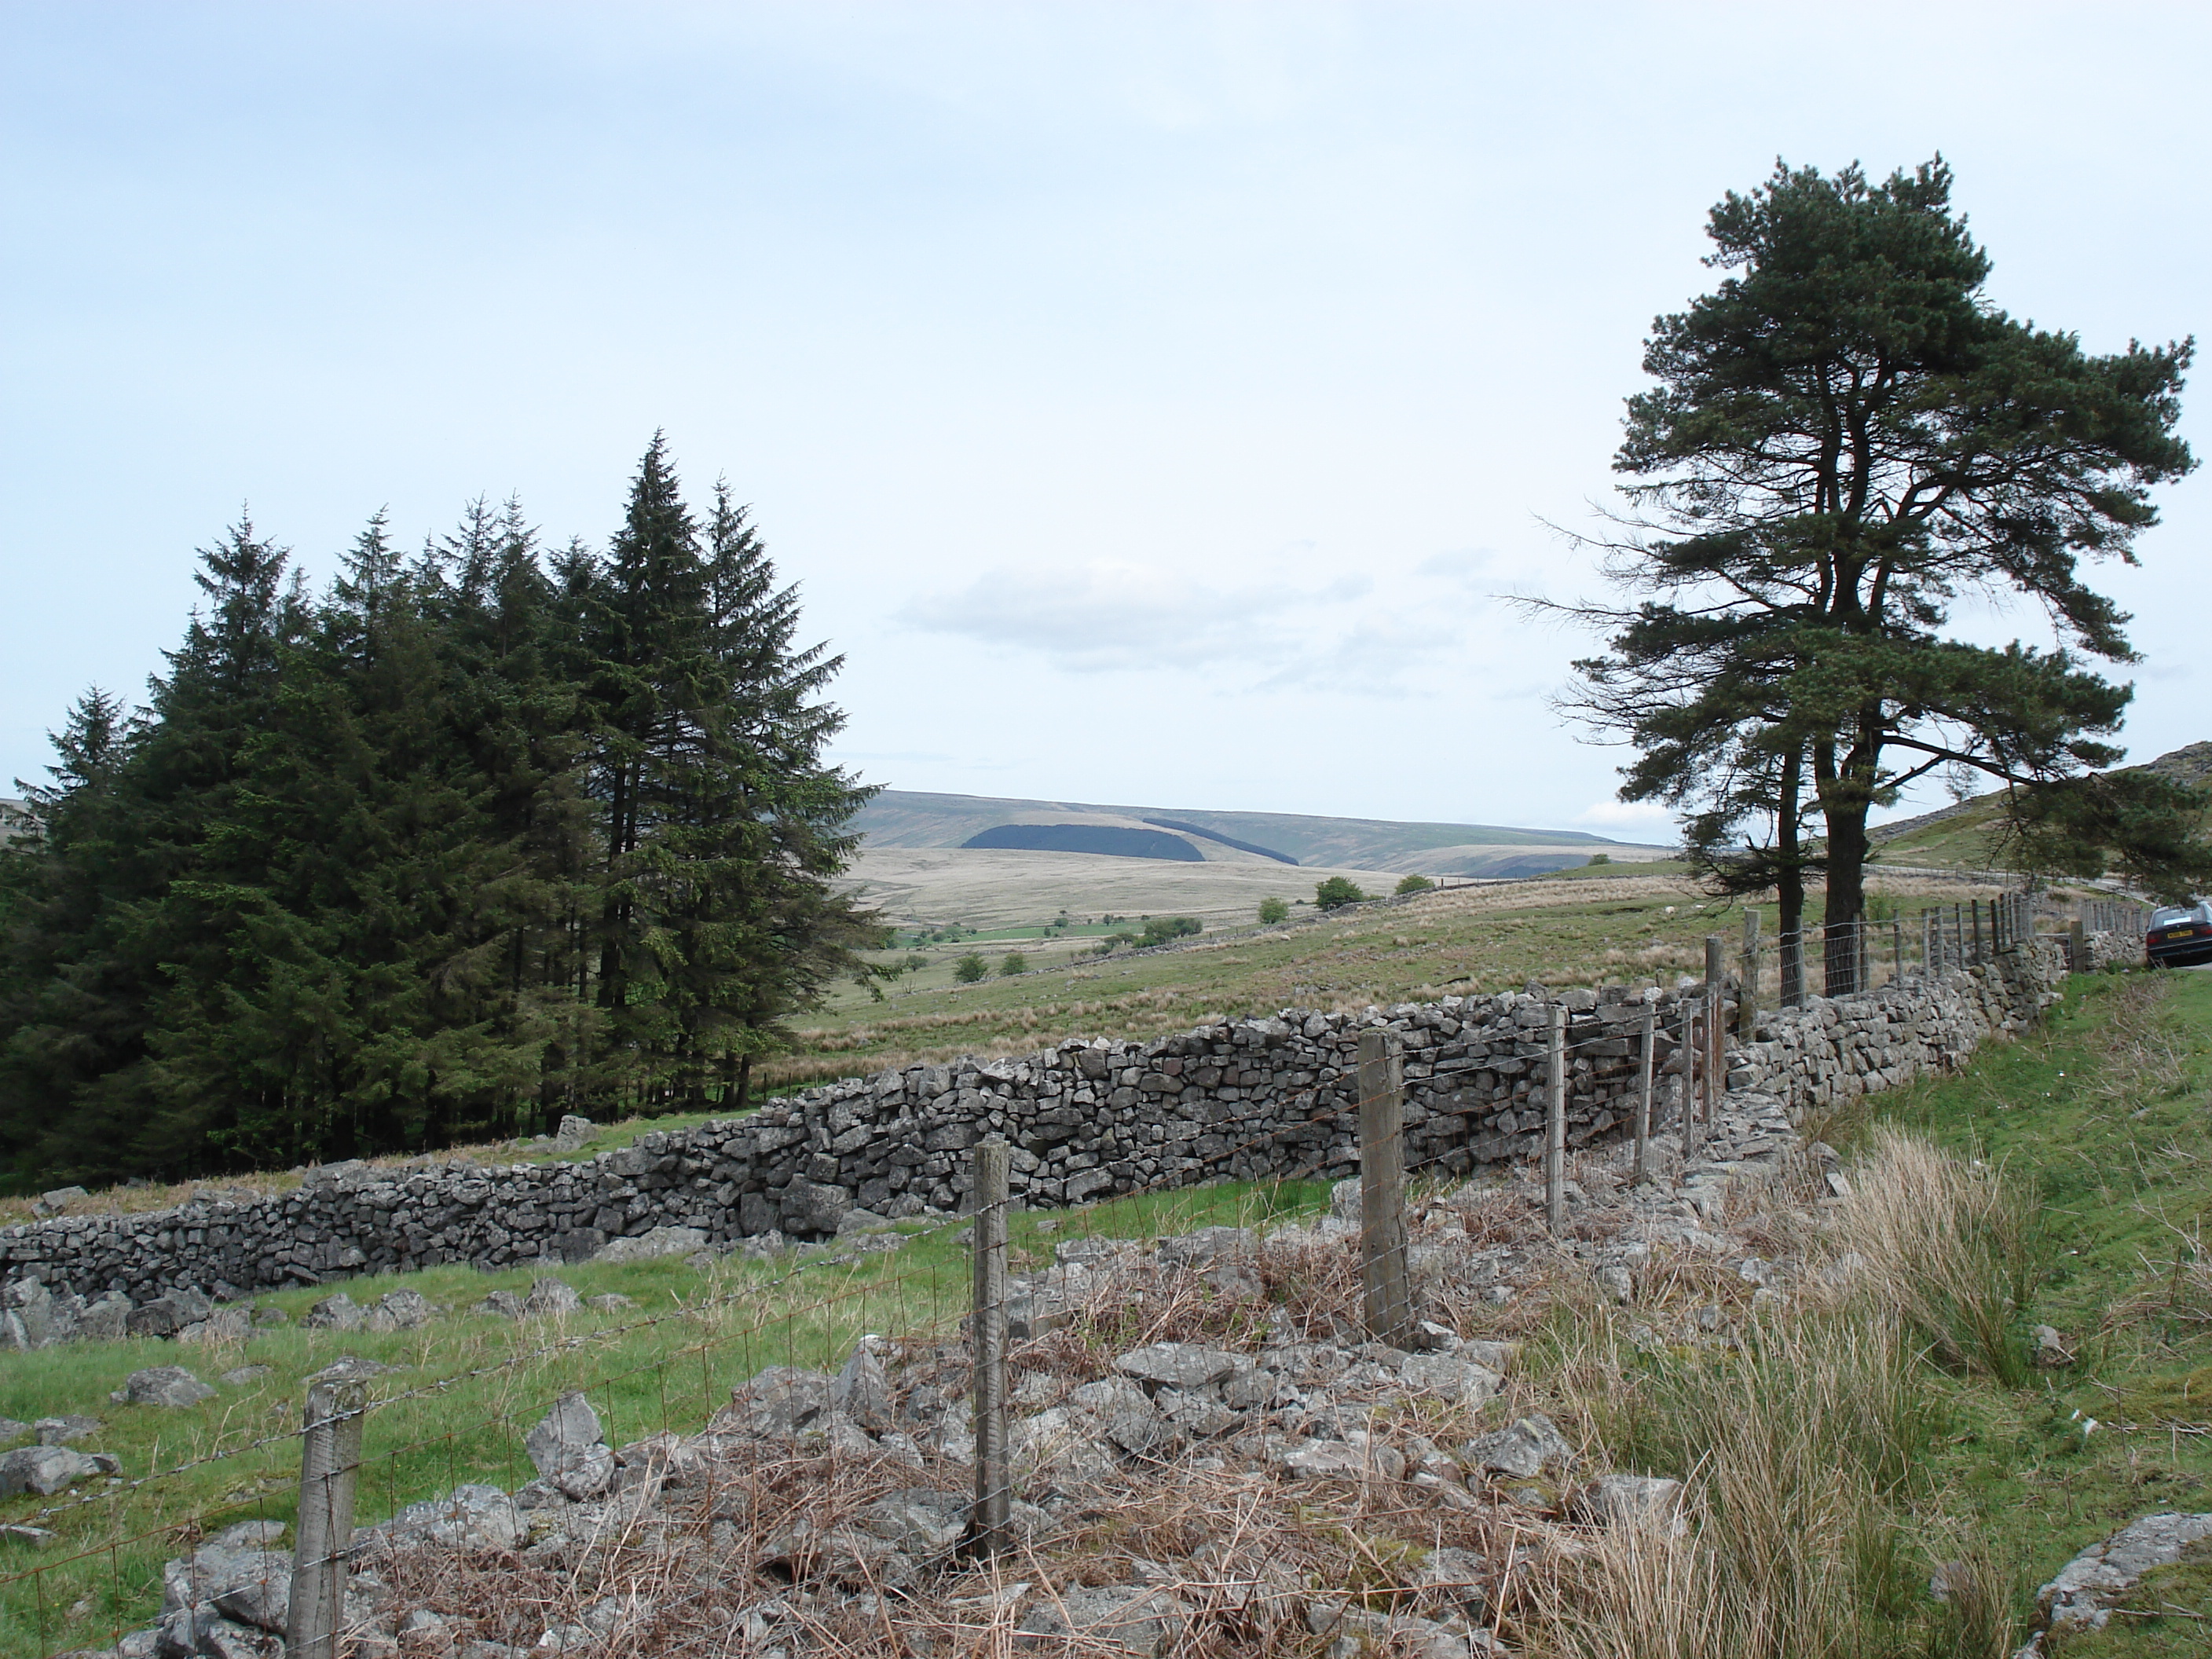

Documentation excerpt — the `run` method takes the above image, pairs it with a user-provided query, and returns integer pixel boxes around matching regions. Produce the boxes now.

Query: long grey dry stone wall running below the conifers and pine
[0,940,2062,1318]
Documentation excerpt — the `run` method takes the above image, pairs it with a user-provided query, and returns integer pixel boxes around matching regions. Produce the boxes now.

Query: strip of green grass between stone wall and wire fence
[0,1181,1328,1654]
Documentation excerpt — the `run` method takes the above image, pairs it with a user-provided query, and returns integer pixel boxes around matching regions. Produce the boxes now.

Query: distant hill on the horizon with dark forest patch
[854,789,1670,876]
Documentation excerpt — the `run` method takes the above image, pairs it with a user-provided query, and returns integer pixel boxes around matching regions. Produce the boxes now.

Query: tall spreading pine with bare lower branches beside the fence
[1566,157,2212,982]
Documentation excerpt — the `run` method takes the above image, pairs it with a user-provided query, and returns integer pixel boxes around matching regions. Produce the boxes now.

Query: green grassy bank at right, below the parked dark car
[1849,973,2212,1659]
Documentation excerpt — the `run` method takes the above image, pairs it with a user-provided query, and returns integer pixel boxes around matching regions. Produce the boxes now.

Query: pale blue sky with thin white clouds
[0,0,2212,838]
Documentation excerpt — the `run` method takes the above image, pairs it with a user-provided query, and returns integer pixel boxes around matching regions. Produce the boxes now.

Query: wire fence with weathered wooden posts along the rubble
[0,895,2144,1659]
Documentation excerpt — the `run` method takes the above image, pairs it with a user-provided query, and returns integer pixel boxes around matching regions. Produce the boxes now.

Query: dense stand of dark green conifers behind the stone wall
[0,438,881,1185]
